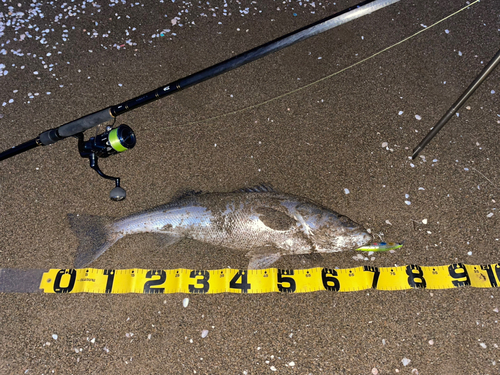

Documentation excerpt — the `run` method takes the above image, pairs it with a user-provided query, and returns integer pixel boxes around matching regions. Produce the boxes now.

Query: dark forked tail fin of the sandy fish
[68,214,120,268]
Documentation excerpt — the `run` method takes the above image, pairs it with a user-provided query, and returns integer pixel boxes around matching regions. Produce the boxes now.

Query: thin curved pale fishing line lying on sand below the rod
[168,0,481,128]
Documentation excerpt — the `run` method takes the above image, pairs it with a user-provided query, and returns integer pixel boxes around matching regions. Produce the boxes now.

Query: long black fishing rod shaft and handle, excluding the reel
[0,0,400,161]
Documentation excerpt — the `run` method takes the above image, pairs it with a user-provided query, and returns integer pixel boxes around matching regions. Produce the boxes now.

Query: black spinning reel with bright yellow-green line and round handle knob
[75,124,136,201]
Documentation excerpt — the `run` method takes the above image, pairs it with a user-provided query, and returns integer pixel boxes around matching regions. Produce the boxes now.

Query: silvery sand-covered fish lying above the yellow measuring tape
[68,184,372,269]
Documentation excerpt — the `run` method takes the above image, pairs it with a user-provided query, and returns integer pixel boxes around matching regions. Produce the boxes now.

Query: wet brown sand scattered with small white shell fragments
[0,0,500,374]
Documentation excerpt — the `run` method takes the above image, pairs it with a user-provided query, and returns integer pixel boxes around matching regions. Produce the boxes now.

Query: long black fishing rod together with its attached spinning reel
[0,0,400,201]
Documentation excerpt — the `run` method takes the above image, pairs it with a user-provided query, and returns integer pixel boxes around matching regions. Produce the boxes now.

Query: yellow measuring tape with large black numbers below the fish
[34,263,500,294]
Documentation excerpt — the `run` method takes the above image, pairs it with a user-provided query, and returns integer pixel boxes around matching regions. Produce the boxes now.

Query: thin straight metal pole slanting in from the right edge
[411,50,500,159]
